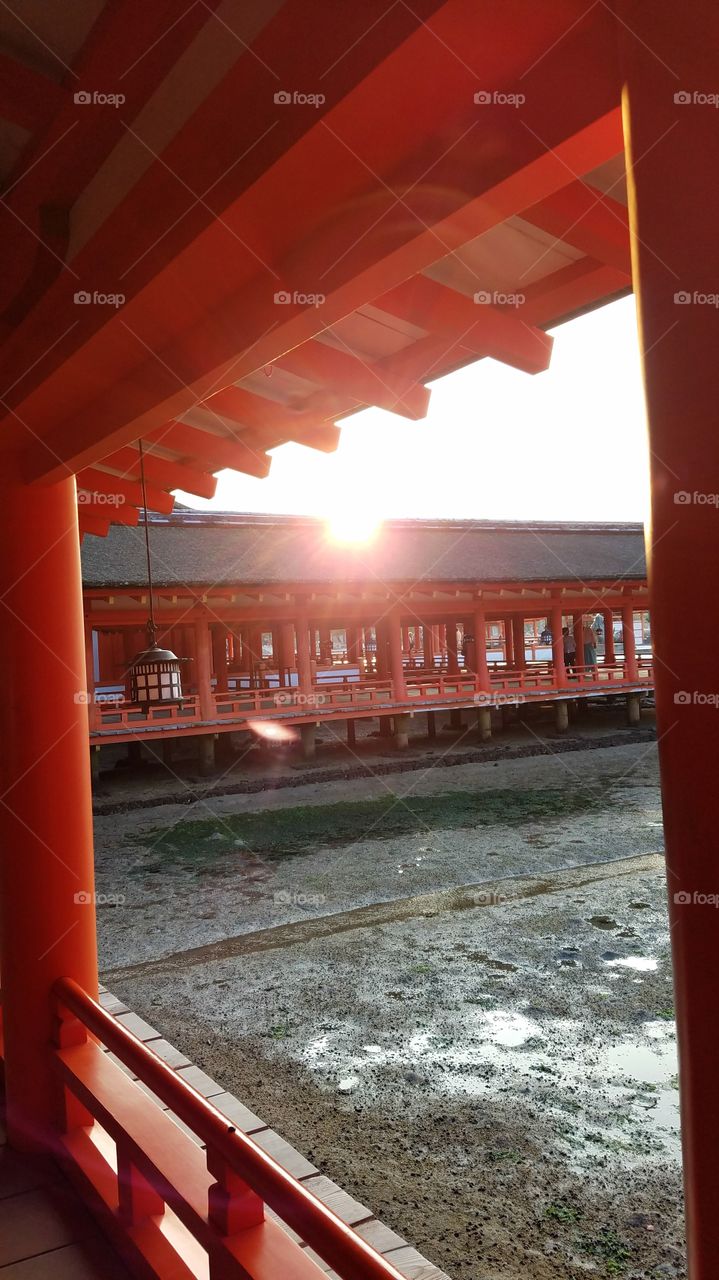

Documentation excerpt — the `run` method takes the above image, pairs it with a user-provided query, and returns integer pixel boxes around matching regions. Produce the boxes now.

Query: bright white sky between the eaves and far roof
[178,297,649,536]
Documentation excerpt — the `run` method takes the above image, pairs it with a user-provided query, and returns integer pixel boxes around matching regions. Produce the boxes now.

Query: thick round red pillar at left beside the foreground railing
[0,454,97,1151]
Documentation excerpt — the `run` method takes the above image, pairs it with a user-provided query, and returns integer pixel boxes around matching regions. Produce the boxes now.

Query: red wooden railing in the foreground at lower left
[52,978,402,1280]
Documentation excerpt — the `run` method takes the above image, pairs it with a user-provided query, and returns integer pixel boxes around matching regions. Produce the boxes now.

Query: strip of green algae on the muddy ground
[133,787,604,861]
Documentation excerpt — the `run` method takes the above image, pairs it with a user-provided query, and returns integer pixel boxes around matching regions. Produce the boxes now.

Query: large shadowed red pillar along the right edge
[619,0,719,1280]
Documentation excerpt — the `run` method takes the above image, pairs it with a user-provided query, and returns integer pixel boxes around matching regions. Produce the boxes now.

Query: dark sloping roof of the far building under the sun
[82,513,646,588]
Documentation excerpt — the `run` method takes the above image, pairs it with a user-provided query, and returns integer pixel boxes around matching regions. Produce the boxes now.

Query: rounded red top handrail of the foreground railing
[52,978,403,1280]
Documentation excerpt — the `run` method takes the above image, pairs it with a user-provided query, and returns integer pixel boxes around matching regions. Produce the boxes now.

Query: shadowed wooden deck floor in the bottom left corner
[0,1129,130,1280]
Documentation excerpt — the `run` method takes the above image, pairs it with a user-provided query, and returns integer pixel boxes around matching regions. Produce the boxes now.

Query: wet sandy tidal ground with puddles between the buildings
[97,727,684,1280]
